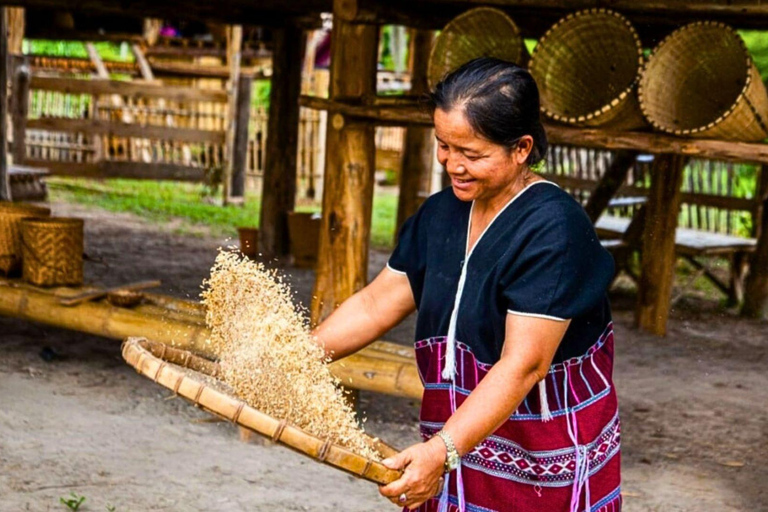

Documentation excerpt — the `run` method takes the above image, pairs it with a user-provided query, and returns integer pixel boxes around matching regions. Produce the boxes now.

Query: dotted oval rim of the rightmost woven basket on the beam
[637,21,768,136]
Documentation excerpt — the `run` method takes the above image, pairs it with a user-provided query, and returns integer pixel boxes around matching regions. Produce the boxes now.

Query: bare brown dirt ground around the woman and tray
[0,204,768,512]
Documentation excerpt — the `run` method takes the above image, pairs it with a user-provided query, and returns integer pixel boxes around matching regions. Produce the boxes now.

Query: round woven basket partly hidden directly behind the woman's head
[427,7,528,89]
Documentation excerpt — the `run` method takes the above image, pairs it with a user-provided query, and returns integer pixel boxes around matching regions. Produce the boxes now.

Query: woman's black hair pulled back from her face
[427,57,547,166]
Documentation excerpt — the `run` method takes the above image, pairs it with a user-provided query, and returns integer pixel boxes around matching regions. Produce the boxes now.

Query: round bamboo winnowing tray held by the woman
[122,338,401,484]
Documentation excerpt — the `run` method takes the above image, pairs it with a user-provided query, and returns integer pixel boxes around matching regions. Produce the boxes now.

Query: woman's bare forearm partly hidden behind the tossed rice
[312,268,416,359]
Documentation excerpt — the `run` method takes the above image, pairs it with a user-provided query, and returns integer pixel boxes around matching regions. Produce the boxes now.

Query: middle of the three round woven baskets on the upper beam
[529,9,646,130]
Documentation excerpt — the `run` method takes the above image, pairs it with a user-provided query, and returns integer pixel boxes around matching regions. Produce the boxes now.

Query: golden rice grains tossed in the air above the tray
[202,251,380,460]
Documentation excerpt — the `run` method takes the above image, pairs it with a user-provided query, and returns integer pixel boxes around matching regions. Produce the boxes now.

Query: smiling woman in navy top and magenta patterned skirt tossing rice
[315,58,621,512]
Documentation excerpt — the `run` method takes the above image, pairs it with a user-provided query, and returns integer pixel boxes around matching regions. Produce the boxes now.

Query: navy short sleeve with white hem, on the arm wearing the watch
[501,203,614,320]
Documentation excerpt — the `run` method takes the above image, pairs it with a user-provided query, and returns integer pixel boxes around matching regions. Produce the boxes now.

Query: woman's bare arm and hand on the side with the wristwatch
[380,314,570,509]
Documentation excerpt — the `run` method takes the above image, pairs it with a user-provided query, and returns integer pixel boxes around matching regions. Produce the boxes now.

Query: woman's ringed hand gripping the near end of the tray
[379,436,446,510]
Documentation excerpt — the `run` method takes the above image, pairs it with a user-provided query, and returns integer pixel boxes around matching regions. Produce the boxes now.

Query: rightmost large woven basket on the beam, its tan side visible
[638,21,768,141]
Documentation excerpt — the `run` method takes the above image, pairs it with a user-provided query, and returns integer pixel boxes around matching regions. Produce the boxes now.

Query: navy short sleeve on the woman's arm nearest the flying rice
[387,203,428,304]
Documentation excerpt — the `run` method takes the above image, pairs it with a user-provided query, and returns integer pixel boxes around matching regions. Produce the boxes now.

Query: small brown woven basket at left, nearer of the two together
[21,218,83,286]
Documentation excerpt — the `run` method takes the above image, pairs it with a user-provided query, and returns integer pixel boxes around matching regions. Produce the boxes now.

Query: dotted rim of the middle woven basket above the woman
[529,8,644,124]
